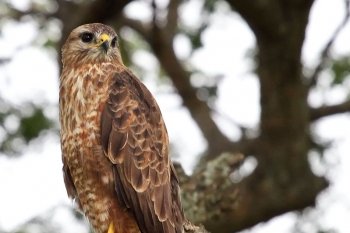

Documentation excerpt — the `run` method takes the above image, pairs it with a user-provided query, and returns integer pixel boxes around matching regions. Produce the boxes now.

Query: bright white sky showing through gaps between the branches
[0,0,350,233]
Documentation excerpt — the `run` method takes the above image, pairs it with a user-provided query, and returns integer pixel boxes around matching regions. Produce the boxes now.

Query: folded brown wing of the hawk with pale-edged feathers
[101,71,183,233]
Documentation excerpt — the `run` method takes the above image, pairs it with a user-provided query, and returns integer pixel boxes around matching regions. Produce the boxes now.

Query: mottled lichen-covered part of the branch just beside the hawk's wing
[175,153,243,232]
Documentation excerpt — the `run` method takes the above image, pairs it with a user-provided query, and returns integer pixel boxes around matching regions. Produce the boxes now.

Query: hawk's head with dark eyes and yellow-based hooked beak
[62,23,122,65]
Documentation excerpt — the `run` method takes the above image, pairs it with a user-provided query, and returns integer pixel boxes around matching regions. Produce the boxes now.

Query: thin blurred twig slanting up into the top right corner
[308,0,350,88]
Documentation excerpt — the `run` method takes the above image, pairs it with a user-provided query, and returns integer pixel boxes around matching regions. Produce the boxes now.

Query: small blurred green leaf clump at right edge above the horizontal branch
[331,56,350,85]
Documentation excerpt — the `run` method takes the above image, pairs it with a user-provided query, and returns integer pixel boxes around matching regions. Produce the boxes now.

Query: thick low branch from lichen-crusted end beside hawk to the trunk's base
[175,150,327,233]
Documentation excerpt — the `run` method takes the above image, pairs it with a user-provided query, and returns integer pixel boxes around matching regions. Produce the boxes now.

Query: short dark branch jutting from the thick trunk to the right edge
[310,100,350,121]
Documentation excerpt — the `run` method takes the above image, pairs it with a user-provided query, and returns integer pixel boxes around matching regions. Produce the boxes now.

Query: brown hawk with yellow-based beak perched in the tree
[59,23,185,233]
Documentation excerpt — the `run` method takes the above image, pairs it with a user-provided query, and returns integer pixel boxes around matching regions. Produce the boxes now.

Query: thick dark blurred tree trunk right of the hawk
[194,0,327,233]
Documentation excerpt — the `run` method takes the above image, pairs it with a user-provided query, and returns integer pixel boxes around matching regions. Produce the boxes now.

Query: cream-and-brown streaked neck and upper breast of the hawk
[59,63,119,142]
